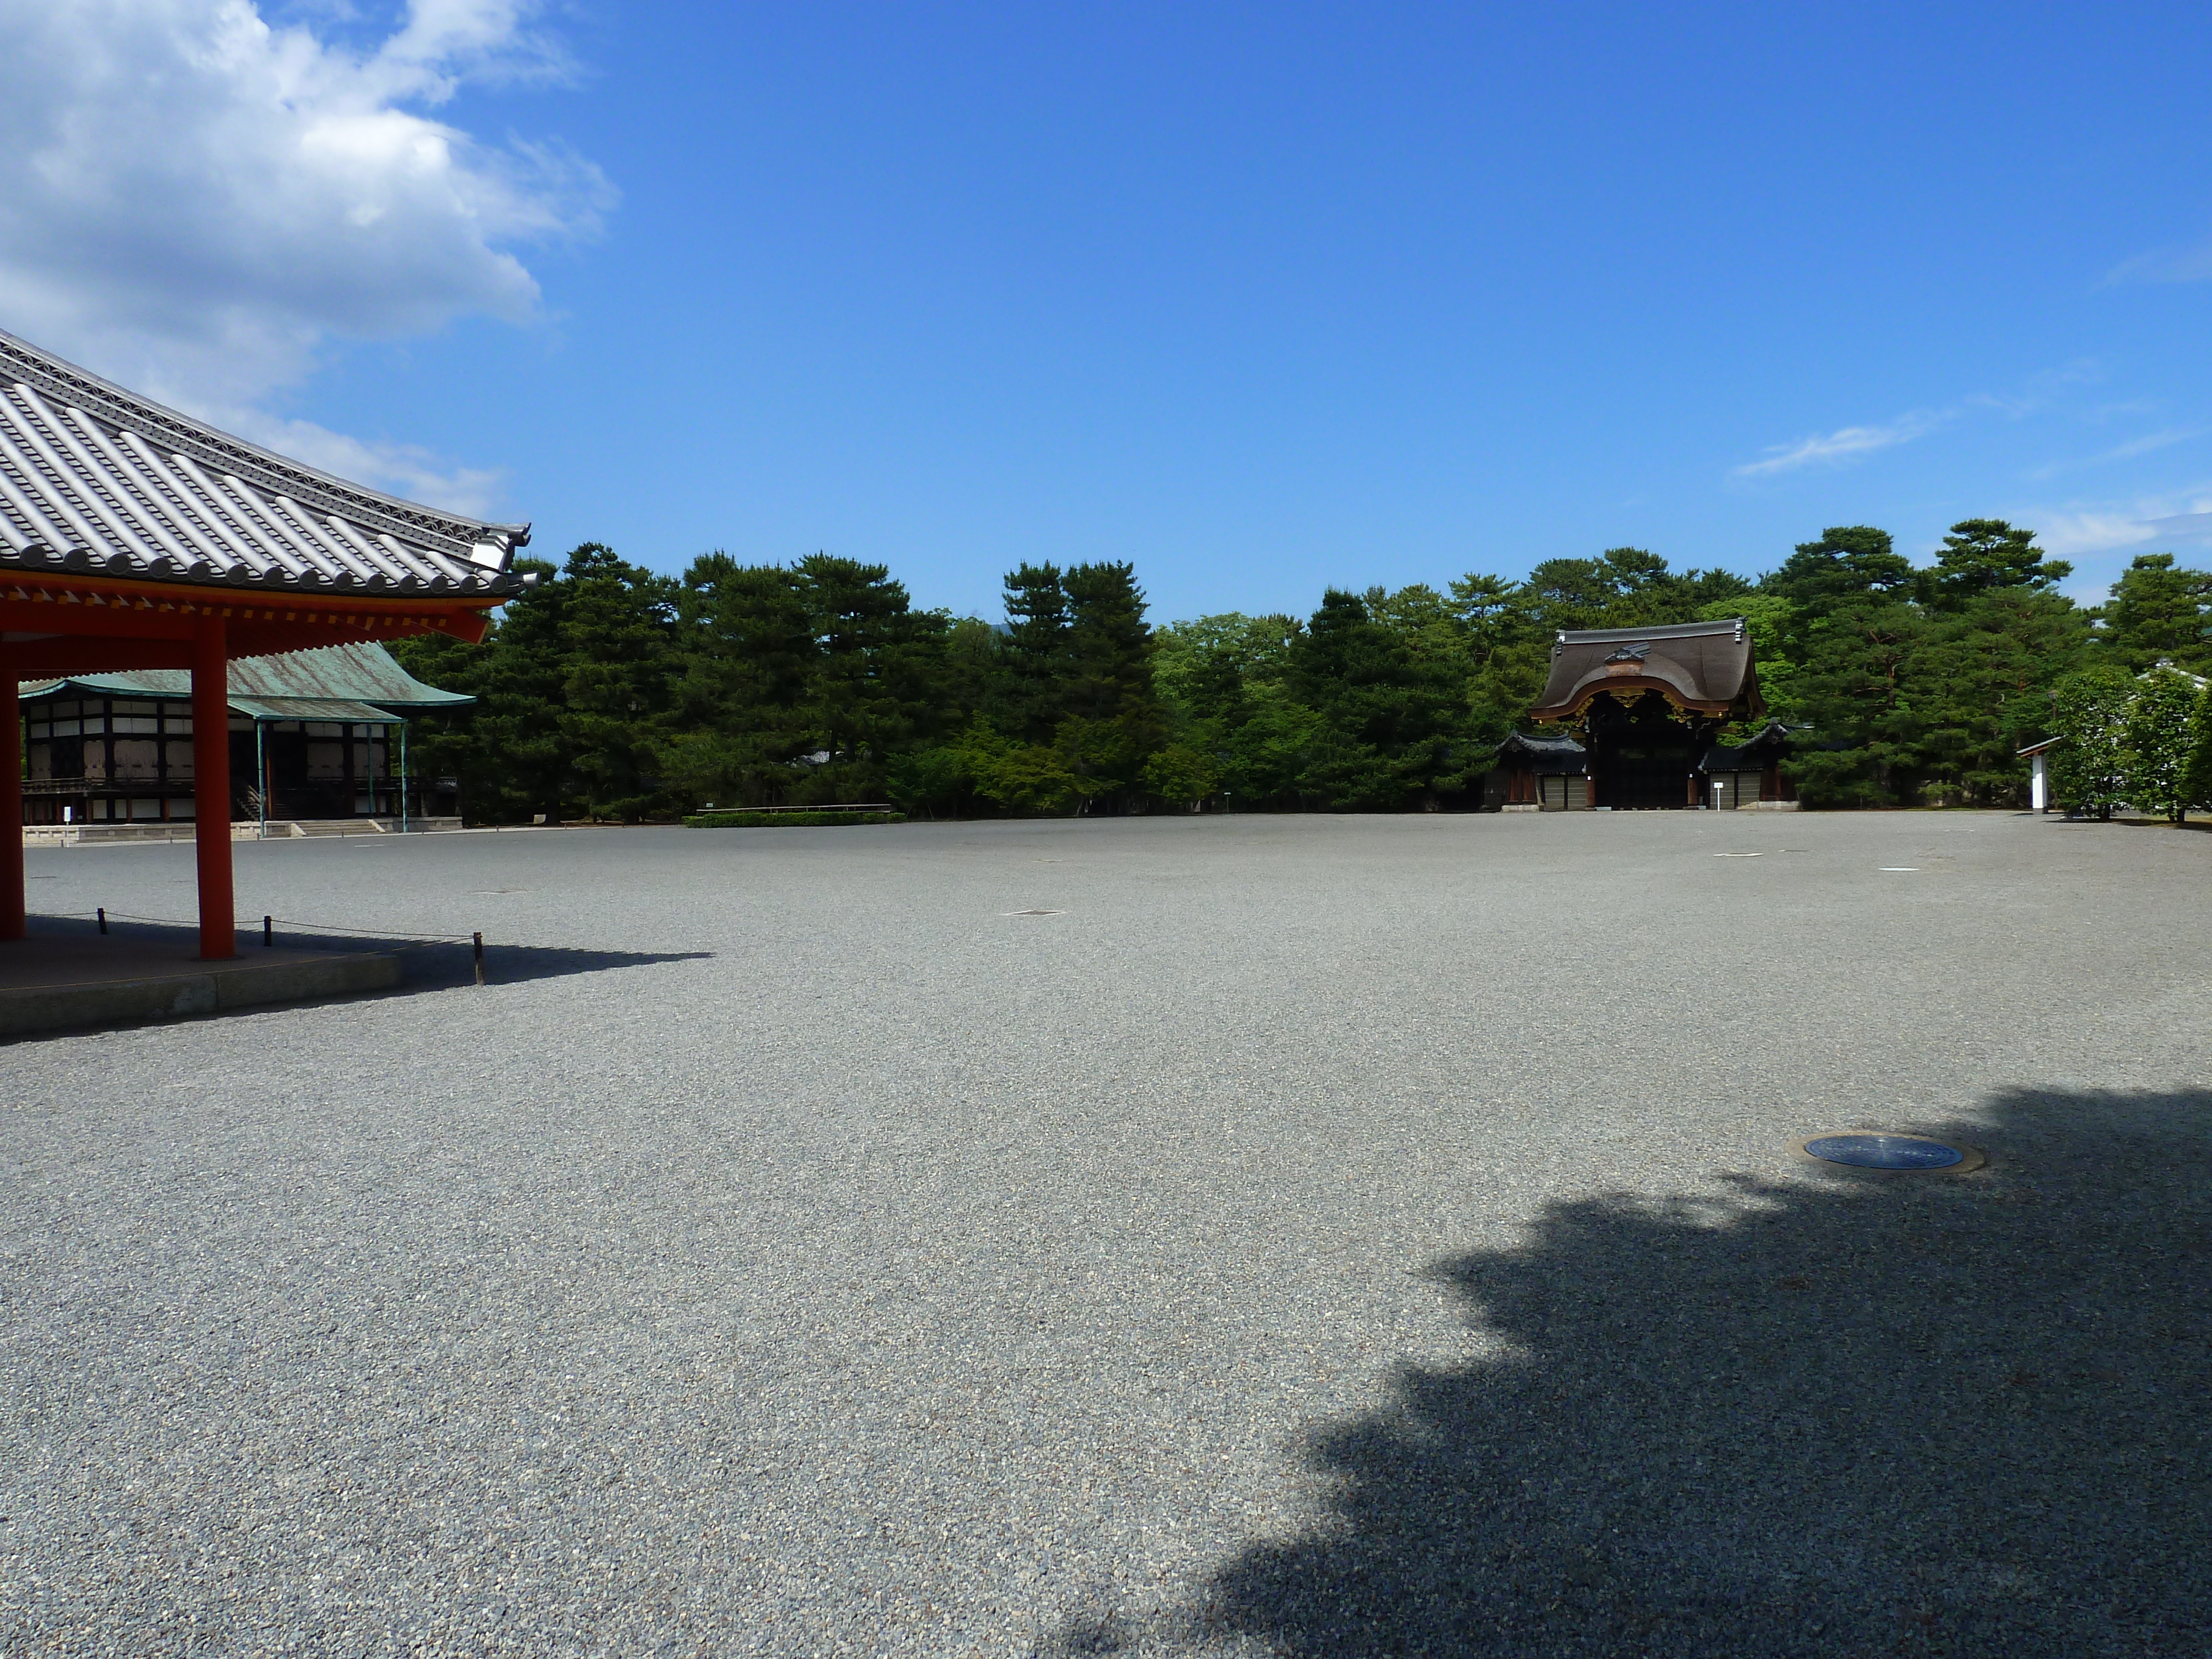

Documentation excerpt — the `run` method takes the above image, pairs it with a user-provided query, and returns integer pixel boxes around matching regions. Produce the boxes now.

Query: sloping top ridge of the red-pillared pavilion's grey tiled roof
[0,330,531,564]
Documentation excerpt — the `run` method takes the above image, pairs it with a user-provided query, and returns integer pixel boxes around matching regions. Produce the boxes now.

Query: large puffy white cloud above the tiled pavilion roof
[0,0,613,504]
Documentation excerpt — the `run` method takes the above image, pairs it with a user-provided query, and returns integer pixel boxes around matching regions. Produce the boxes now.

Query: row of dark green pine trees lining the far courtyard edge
[398,520,2212,821]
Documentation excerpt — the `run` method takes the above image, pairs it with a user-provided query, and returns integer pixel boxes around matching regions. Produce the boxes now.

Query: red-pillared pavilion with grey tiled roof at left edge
[0,323,531,960]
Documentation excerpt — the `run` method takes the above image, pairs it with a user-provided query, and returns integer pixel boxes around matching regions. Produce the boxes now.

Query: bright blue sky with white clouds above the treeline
[0,0,2212,619]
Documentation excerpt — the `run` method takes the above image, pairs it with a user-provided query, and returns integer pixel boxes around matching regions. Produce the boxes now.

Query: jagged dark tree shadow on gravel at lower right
[1044,1091,2212,1657]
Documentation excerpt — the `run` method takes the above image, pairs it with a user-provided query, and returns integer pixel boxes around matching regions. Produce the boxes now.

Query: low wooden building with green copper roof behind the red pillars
[20,644,476,825]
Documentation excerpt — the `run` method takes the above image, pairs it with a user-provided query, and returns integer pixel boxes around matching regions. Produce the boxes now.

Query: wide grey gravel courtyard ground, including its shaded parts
[0,814,2212,1655]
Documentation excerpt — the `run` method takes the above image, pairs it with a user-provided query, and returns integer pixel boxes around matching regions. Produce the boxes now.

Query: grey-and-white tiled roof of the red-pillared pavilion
[0,332,531,599]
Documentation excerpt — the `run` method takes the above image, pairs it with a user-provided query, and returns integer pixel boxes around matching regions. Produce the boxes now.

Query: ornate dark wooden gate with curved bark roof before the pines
[1491,617,1794,812]
